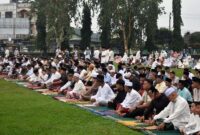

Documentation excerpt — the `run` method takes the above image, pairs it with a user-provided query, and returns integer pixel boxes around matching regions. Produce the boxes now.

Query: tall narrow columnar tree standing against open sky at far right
[171,0,184,50]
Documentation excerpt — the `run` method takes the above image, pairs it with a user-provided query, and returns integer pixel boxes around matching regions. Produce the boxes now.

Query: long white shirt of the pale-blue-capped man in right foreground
[154,96,190,129]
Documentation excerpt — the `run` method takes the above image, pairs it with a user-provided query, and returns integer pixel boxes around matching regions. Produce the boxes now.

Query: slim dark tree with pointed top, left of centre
[81,2,92,50]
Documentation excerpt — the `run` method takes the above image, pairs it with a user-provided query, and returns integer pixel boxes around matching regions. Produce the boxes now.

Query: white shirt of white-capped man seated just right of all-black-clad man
[121,89,142,109]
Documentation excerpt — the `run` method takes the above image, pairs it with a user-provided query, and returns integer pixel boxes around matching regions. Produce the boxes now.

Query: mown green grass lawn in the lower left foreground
[0,80,140,135]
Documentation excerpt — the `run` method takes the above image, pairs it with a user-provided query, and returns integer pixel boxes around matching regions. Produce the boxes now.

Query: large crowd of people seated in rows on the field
[0,48,200,135]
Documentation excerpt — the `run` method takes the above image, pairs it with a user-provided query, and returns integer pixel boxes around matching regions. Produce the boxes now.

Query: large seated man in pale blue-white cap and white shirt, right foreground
[154,87,190,130]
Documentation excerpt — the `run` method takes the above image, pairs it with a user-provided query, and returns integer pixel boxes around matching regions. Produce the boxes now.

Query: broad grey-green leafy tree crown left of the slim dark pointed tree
[46,0,79,48]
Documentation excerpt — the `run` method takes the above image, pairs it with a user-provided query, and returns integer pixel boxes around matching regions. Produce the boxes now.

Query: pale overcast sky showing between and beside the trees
[0,0,200,34]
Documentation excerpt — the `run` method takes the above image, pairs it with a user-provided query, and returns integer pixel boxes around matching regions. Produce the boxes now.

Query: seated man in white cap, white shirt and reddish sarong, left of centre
[66,73,85,99]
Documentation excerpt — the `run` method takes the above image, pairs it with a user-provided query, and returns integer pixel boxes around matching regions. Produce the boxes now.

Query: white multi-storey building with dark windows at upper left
[0,2,36,40]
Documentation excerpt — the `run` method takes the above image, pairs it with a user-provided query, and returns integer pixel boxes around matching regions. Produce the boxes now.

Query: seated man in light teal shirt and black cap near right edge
[178,80,193,103]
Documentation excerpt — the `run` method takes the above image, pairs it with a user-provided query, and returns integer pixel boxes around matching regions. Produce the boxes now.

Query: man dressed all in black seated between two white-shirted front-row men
[108,79,126,109]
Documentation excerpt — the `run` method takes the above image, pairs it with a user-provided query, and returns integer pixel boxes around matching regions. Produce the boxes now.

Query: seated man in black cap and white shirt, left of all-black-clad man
[91,75,115,106]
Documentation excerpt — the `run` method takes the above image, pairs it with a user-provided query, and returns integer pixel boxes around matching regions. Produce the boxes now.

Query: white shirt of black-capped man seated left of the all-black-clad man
[91,83,115,104]
